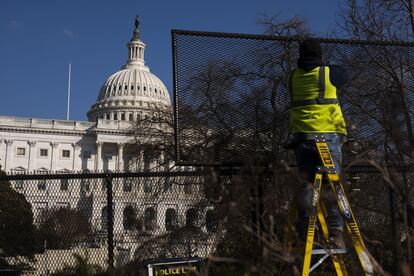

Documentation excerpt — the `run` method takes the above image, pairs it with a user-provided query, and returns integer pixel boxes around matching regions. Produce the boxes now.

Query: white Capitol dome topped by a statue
[87,17,171,121]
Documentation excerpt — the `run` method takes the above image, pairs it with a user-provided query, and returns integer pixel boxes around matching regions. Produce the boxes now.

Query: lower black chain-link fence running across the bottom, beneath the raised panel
[0,166,414,275]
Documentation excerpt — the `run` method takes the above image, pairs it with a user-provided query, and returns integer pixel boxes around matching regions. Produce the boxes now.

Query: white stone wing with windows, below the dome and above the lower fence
[0,116,134,172]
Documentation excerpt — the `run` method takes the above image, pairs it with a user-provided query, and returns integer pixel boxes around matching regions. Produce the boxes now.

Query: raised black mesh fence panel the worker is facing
[172,30,414,167]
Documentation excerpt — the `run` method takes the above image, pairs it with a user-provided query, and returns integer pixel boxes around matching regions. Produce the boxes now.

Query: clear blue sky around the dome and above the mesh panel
[0,0,338,120]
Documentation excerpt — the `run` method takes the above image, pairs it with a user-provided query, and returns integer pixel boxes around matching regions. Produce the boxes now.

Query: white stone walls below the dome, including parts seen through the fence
[0,116,213,252]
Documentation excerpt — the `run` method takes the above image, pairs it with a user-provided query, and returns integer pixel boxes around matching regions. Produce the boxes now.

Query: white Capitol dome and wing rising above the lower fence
[0,17,171,175]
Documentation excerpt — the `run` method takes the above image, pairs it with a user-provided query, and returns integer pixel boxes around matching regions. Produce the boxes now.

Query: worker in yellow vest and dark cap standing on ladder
[288,39,349,248]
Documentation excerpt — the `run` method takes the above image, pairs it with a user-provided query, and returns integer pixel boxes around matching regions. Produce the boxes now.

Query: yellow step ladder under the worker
[285,135,374,275]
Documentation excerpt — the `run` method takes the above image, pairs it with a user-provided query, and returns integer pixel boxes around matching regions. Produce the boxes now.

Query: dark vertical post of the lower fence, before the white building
[105,174,114,270]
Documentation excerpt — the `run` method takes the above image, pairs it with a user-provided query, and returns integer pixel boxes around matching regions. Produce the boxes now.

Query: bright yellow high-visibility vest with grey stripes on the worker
[288,66,346,134]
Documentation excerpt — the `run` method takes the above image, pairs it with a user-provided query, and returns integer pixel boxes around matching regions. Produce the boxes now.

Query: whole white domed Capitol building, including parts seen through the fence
[0,18,213,268]
